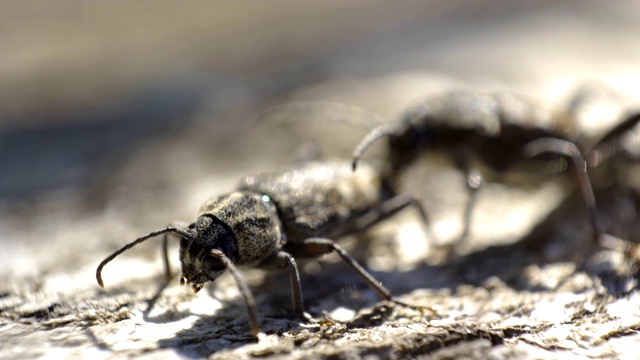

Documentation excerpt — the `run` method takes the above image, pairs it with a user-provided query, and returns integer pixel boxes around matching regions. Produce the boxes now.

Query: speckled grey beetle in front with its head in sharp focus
[96,161,427,336]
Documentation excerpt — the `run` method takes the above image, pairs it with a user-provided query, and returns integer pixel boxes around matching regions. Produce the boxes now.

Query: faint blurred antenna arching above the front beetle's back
[257,101,387,129]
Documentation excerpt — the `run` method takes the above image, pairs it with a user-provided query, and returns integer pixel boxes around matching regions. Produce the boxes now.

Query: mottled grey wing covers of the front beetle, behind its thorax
[238,161,386,242]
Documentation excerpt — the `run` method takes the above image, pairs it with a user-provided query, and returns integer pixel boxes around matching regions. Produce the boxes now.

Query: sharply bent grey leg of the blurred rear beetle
[524,138,604,239]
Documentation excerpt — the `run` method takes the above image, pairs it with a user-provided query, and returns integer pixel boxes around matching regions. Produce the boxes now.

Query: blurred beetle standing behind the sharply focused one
[352,84,640,245]
